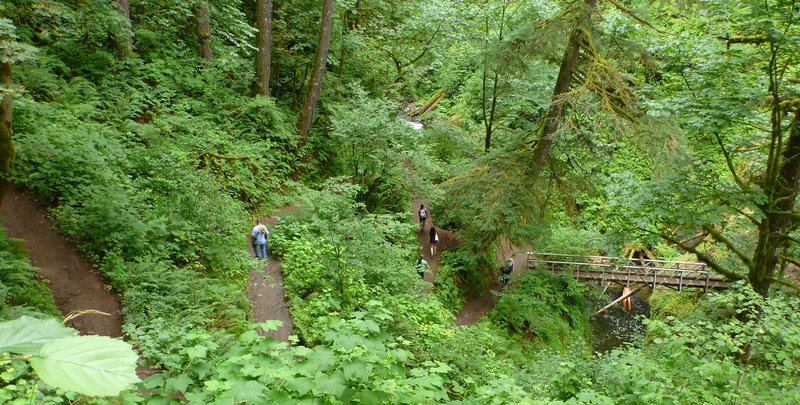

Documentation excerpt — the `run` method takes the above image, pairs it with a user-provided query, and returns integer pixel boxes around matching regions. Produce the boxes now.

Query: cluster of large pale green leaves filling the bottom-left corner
[0,316,139,399]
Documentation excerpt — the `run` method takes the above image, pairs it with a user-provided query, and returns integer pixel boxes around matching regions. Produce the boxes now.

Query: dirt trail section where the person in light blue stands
[247,205,298,342]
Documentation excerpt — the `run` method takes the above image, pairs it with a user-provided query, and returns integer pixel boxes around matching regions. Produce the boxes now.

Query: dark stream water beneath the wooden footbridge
[589,290,650,353]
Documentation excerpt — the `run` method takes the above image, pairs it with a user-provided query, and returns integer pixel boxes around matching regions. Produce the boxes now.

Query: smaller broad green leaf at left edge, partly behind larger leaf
[0,316,77,354]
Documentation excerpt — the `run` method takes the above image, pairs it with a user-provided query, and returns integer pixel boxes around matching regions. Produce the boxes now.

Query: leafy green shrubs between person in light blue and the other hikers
[271,182,445,344]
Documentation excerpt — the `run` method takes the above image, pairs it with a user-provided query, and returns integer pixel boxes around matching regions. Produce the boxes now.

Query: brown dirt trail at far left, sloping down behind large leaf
[2,184,122,337]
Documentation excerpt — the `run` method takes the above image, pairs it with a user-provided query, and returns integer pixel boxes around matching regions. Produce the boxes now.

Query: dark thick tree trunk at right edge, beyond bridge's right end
[748,105,800,297]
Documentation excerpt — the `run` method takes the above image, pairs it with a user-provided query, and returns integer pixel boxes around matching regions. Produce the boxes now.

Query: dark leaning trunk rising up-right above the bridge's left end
[533,0,597,169]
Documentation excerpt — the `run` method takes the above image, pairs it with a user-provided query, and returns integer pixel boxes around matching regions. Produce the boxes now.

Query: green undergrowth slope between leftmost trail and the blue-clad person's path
[7,46,288,367]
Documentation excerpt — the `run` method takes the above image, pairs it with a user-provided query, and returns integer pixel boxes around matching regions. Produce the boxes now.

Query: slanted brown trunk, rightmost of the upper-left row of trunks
[297,0,334,148]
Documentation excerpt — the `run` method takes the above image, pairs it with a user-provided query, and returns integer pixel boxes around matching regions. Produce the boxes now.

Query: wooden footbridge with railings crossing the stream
[528,252,729,292]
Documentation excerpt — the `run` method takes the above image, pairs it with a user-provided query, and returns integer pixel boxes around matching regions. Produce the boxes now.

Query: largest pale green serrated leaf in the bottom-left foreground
[30,336,139,396]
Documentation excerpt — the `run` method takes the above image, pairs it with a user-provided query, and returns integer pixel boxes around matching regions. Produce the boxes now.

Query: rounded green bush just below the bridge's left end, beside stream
[489,271,591,348]
